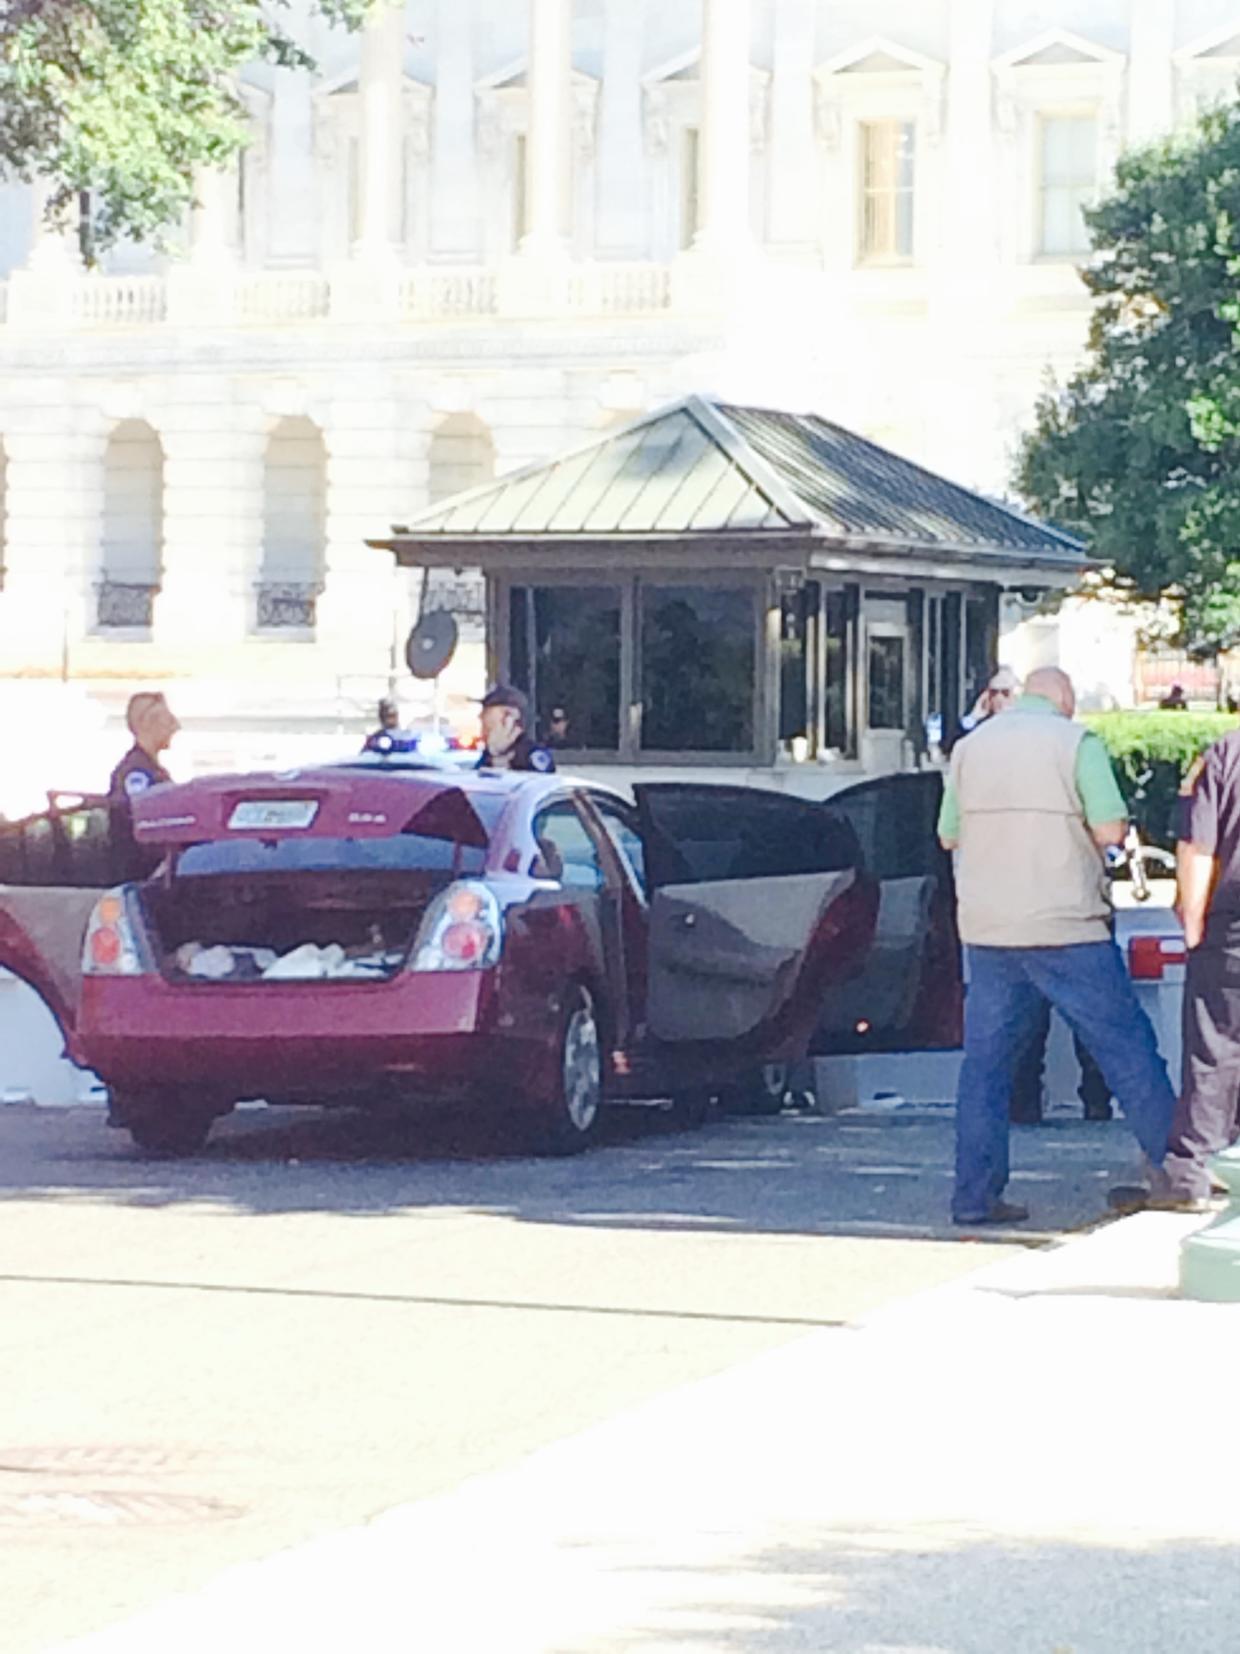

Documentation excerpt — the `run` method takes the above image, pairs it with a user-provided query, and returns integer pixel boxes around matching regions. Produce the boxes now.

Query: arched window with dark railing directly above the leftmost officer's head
[96,418,164,630]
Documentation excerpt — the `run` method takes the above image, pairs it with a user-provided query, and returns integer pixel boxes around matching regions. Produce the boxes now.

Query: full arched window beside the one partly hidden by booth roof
[256,418,327,632]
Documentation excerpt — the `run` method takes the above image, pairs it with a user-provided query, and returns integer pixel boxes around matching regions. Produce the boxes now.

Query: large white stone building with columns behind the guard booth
[0,0,1240,809]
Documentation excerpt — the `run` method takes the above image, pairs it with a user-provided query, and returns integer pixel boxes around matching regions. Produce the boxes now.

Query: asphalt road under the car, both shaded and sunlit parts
[0,1107,1129,1654]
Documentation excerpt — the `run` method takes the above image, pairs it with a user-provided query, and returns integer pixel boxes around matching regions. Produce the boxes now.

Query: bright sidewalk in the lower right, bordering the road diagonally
[60,1212,1240,1654]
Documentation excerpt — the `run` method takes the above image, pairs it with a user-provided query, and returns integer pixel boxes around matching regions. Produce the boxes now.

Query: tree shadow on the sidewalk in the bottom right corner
[542,1523,1240,1654]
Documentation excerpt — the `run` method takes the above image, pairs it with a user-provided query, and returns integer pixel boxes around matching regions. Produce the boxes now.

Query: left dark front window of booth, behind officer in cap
[509,586,620,753]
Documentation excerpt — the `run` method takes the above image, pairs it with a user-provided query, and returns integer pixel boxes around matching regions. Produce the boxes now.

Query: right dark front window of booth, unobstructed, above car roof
[640,586,757,753]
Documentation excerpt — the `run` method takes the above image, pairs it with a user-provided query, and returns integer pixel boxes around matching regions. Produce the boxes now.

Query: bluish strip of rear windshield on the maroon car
[177,834,486,878]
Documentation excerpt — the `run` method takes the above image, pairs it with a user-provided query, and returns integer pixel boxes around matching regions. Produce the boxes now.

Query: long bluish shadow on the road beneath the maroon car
[0,1107,1133,1244]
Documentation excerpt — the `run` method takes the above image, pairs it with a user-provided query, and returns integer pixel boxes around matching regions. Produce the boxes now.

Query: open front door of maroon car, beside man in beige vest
[812,771,964,1055]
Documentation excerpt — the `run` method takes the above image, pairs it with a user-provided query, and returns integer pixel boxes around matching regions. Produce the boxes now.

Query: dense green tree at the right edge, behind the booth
[1017,103,1240,653]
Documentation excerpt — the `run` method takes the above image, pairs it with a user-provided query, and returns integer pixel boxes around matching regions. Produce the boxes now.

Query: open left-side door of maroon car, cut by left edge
[0,794,114,1057]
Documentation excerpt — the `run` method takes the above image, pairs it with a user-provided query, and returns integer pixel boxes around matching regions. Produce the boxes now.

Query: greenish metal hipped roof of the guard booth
[372,395,1086,569]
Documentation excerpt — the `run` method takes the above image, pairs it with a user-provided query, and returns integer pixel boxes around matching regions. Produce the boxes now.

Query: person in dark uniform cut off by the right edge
[1154,729,1240,1211]
